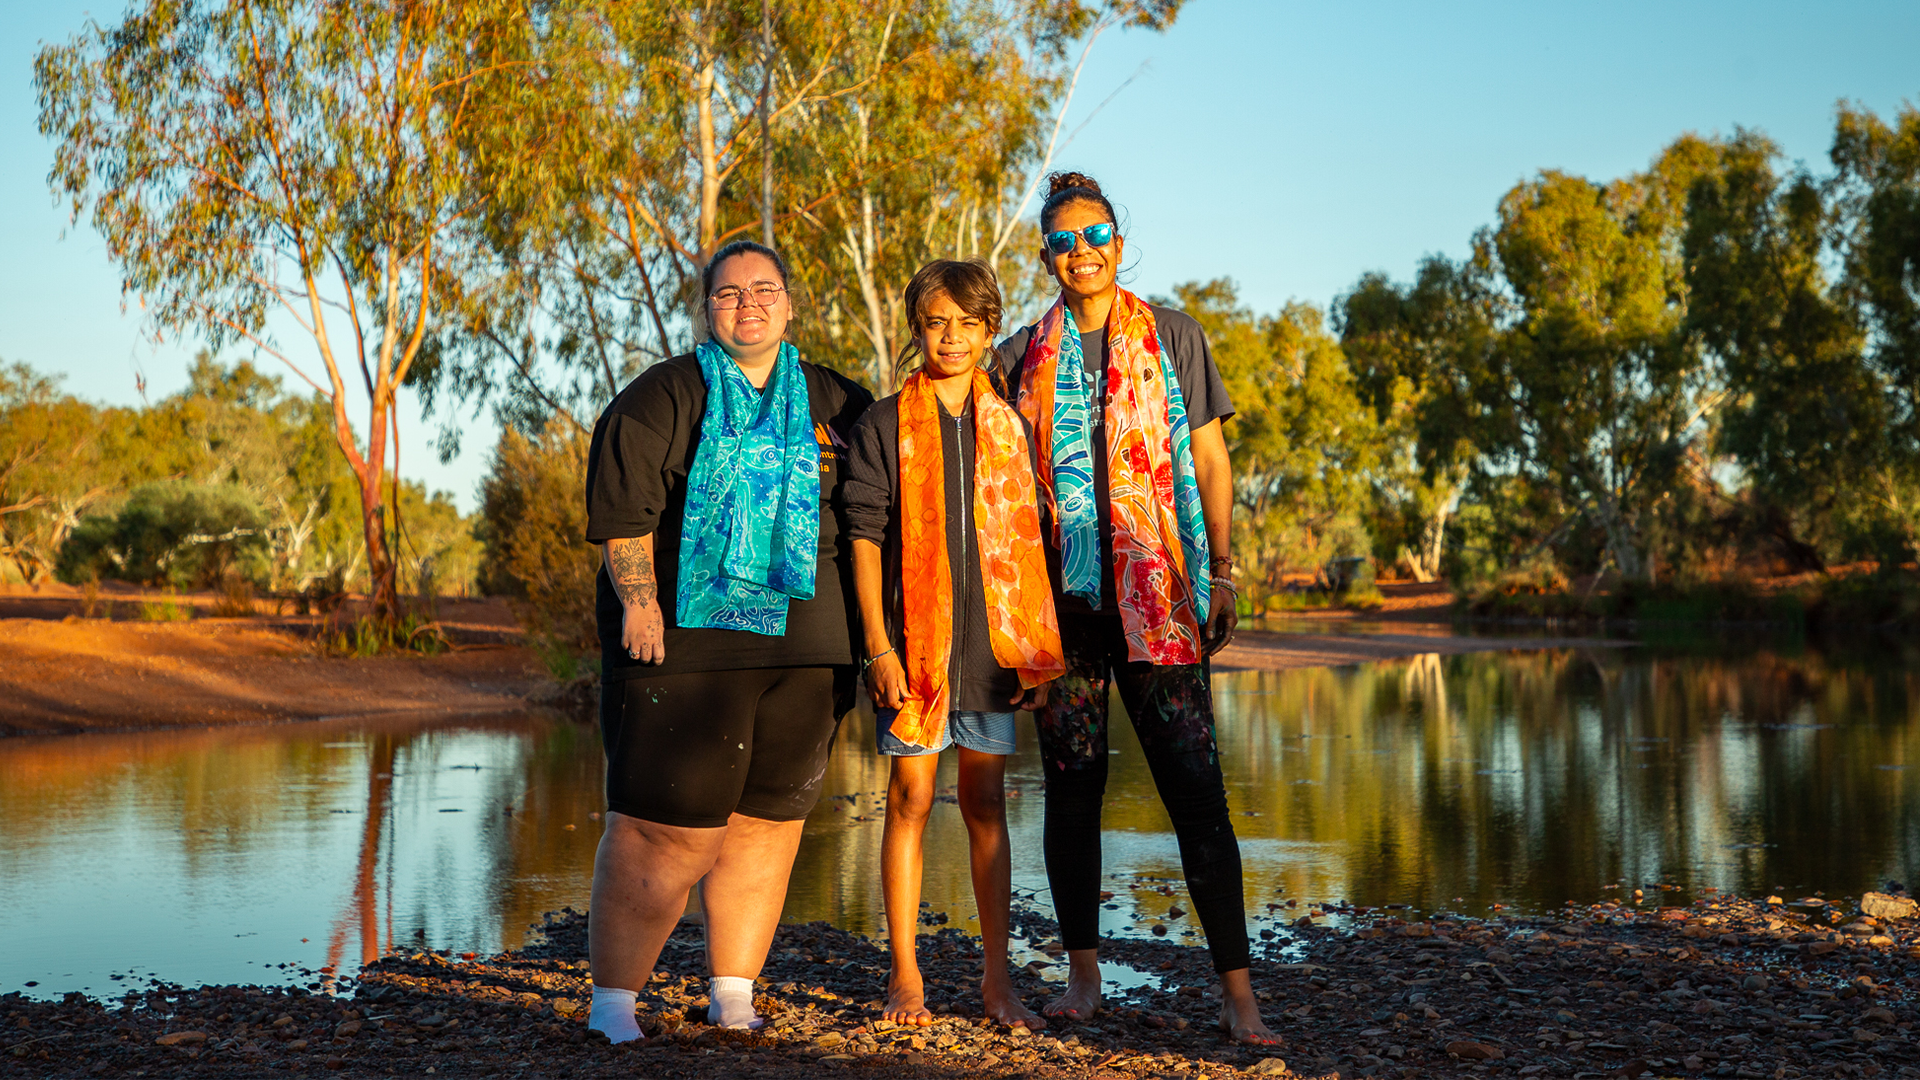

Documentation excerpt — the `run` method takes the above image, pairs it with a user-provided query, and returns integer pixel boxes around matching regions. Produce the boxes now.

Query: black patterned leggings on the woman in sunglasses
[1037,613,1250,970]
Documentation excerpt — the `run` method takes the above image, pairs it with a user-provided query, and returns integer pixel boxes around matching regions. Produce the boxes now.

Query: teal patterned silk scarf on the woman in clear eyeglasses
[674,340,820,638]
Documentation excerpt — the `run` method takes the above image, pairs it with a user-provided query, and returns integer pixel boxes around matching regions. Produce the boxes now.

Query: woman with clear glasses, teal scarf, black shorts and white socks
[588,240,874,1042]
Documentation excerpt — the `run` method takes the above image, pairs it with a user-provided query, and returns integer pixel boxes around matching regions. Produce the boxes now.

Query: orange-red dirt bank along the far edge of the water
[0,590,1620,736]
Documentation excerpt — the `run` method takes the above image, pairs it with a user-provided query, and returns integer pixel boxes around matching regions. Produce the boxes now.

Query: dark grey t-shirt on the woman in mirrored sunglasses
[995,304,1233,613]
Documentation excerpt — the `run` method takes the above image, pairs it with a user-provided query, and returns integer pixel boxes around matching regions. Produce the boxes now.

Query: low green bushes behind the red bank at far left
[0,356,480,596]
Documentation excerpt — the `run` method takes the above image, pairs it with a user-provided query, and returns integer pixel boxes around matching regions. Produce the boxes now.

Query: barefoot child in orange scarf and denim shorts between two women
[845,259,1064,1030]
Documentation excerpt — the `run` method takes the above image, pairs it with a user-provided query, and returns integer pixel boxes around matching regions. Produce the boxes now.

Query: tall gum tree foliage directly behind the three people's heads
[417,0,1181,428]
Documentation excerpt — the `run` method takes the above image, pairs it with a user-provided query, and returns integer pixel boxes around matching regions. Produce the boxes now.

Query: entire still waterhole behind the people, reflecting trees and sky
[0,634,1920,995]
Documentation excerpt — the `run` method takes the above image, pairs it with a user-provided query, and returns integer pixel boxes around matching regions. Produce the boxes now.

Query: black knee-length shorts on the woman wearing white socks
[601,667,839,828]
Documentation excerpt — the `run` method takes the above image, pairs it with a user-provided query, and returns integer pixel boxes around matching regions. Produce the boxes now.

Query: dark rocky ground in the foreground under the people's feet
[0,890,1920,1080]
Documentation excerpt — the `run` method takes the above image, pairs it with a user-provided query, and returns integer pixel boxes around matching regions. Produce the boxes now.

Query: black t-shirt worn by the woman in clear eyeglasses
[588,356,874,678]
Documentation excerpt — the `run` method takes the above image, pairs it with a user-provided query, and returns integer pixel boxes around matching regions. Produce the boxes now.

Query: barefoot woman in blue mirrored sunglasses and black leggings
[996,173,1279,1045]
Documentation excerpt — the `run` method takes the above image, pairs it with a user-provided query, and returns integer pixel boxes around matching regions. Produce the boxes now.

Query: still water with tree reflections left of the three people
[0,719,599,994]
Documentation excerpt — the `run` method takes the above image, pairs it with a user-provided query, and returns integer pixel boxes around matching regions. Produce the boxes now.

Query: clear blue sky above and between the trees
[0,0,1920,509]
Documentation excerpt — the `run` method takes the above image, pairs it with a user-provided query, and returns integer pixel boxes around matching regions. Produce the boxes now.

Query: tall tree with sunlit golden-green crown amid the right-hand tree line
[1475,136,1715,578]
